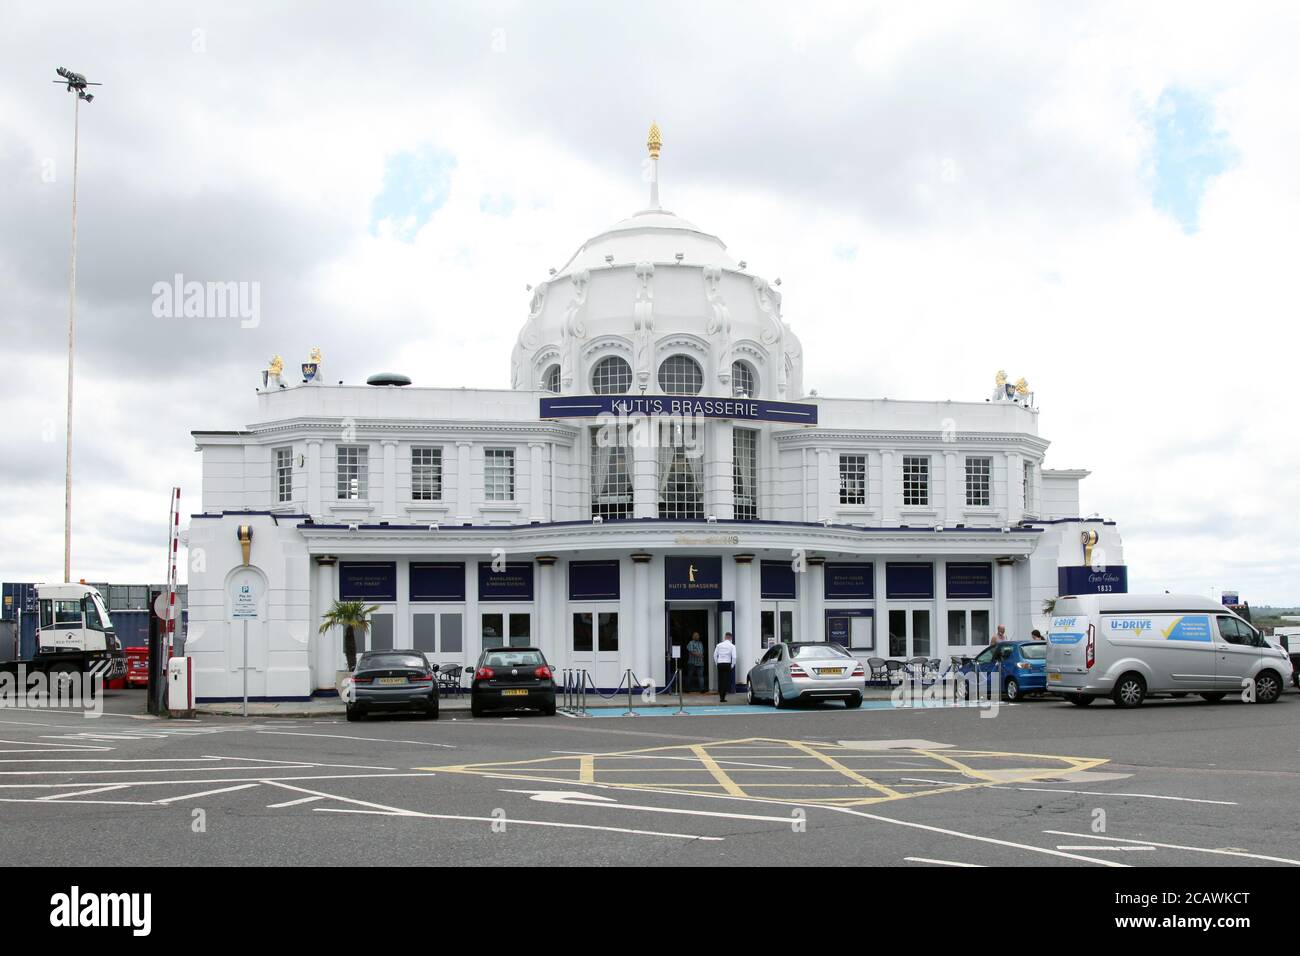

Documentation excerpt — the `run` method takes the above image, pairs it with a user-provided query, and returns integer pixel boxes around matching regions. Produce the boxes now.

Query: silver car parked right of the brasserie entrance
[748,643,867,708]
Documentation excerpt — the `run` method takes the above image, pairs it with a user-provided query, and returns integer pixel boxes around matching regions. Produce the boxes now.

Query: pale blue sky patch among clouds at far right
[1149,87,1236,234]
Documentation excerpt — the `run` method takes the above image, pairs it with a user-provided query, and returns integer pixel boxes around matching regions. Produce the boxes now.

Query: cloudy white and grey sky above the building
[0,0,1300,605]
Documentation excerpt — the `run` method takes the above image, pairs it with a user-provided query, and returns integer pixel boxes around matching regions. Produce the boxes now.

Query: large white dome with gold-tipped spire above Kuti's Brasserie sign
[511,129,803,399]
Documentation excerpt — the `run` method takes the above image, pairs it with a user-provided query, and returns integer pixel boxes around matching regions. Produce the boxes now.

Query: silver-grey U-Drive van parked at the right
[1048,594,1291,708]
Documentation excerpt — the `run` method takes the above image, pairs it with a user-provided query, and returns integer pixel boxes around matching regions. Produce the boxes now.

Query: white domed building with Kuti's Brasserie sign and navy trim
[186,127,1126,700]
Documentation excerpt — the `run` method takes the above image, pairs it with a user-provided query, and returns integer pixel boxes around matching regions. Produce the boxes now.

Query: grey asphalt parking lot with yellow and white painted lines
[0,691,1300,866]
